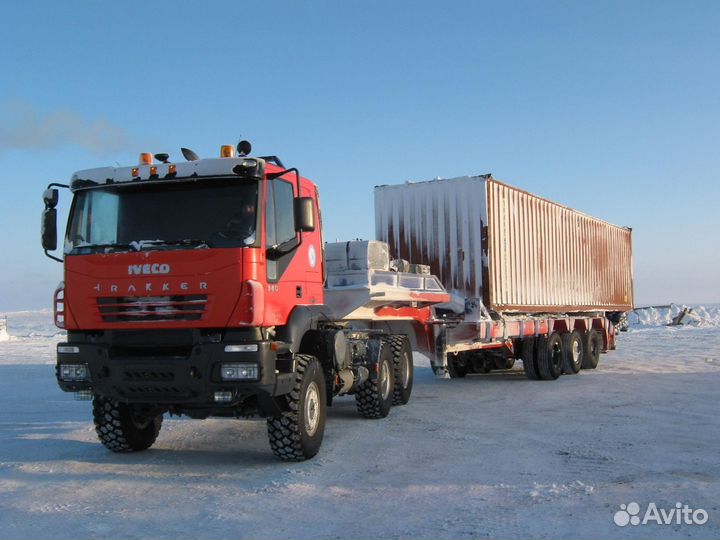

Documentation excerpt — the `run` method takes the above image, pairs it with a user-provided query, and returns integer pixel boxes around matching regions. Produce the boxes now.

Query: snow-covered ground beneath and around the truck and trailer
[0,306,720,539]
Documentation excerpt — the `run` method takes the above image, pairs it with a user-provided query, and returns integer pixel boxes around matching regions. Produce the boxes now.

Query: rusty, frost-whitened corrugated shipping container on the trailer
[375,175,633,313]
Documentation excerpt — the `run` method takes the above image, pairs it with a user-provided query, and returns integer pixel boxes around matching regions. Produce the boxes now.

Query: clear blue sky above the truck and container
[0,0,720,310]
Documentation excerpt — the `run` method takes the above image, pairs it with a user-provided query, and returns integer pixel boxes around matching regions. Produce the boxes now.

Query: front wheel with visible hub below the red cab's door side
[267,354,327,461]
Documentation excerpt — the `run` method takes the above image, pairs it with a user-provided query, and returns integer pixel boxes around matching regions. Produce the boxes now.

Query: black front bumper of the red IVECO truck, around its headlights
[56,338,294,408]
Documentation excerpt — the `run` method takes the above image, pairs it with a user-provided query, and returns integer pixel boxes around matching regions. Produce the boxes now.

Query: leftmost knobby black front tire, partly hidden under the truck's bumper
[93,396,162,452]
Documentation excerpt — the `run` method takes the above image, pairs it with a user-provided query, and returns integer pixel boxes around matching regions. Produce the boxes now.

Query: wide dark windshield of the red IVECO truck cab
[65,179,258,254]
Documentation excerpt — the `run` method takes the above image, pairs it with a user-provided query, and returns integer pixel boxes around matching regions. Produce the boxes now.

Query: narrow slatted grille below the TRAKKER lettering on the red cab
[97,294,207,323]
